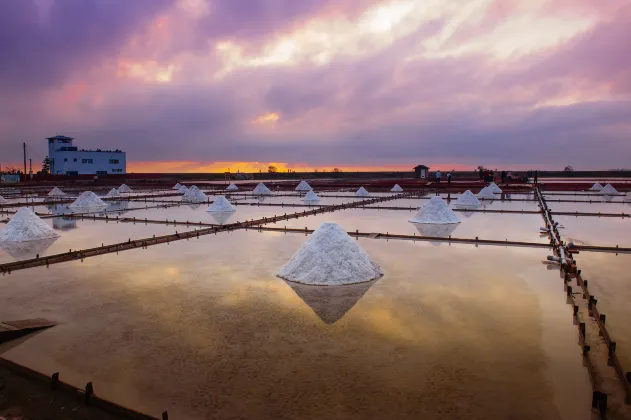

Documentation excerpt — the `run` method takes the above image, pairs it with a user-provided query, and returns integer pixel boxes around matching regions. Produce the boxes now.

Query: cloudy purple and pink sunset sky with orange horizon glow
[0,0,631,172]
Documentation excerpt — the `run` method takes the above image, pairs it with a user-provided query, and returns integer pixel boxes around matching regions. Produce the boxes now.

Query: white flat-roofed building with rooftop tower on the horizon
[47,136,127,175]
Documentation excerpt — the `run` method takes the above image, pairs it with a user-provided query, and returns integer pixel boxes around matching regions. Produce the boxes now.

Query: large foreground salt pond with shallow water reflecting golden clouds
[0,231,591,420]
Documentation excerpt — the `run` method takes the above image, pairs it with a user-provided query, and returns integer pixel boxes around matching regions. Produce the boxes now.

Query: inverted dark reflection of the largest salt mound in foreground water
[283,279,380,324]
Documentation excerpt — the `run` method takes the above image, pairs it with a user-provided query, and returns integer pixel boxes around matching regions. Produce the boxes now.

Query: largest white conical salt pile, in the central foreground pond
[278,222,383,286]
